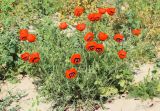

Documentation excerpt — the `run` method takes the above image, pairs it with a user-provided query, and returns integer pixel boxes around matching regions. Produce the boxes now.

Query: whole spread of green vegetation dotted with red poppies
[0,0,159,110]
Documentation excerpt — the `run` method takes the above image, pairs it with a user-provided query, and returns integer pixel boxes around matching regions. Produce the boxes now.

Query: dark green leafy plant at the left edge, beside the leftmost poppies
[0,26,19,79]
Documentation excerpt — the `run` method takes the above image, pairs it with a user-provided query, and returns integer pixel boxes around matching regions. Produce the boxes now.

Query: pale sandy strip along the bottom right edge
[98,98,160,111]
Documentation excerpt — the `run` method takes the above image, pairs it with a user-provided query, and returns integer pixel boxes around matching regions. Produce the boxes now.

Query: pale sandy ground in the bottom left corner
[0,76,51,111]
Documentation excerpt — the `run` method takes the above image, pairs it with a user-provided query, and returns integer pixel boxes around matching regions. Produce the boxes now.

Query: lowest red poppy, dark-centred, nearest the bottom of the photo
[66,68,77,79]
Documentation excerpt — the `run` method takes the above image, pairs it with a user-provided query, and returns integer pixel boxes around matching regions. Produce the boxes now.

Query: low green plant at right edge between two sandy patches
[129,60,160,99]
